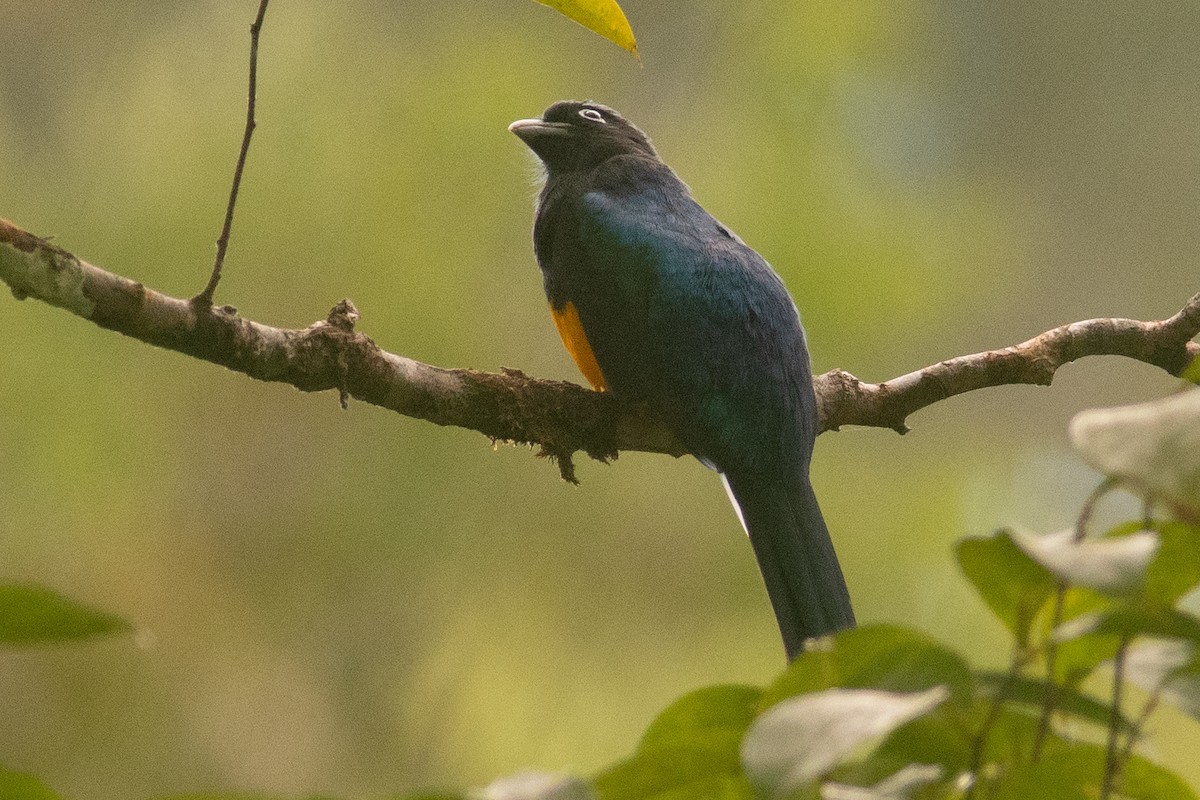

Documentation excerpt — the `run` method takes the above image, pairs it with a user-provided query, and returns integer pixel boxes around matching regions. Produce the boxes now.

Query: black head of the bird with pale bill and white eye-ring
[509,100,658,174]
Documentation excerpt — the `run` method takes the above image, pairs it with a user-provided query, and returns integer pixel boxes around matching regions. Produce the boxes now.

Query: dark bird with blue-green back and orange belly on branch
[509,101,854,661]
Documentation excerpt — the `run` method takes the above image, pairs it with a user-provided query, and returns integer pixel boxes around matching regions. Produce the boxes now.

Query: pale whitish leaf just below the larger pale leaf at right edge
[1012,529,1159,594]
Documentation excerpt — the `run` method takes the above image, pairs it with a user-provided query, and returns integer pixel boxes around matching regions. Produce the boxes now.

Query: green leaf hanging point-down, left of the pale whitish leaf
[958,530,1058,645]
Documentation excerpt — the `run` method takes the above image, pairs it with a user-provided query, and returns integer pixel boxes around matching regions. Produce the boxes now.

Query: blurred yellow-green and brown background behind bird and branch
[0,0,1200,800]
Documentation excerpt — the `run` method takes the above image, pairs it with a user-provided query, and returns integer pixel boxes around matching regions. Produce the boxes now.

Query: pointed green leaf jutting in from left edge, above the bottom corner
[0,585,130,644]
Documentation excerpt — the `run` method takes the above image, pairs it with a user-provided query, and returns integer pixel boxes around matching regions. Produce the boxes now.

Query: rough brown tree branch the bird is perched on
[0,219,1200,481]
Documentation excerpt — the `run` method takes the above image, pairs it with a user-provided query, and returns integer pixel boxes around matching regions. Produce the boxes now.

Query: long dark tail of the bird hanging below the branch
[724,475,854,660]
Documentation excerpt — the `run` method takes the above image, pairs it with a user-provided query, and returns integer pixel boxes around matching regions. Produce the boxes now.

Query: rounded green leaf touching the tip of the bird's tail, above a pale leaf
[760,625,974,708]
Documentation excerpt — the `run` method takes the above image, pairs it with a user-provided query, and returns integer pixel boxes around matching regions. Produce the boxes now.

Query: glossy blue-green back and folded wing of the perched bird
[572,184,815,468]
